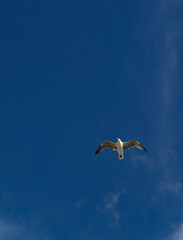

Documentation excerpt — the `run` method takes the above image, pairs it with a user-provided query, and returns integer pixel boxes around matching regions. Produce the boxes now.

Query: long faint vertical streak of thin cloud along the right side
[156,0,182,197]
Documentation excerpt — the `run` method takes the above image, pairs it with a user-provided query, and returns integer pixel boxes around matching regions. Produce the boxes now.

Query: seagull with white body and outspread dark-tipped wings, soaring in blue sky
[95,138,147,159]
